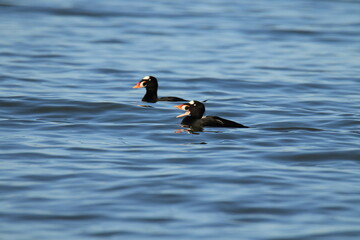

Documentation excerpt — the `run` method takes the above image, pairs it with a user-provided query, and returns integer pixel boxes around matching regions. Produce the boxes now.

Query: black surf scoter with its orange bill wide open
[175,101,248,130]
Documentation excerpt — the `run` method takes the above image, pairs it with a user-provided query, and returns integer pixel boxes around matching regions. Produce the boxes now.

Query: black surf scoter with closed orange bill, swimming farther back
[133,76,187,103]
